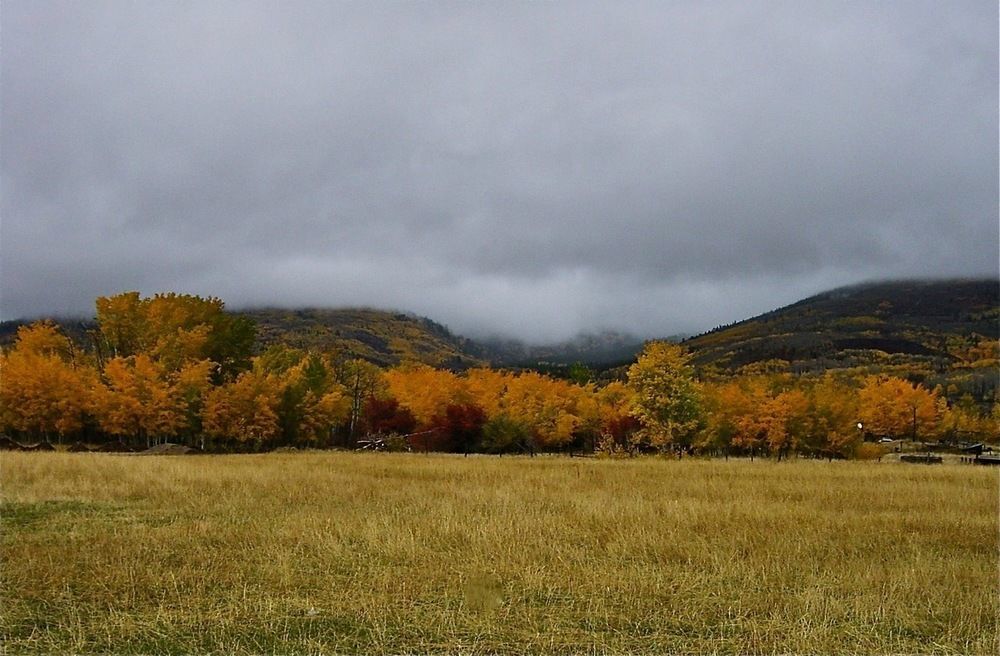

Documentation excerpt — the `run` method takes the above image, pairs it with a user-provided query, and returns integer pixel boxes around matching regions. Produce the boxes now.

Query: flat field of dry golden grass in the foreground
[0,453,1000,654]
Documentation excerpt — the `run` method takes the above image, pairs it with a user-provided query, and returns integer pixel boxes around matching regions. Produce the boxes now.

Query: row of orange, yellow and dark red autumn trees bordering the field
[0,292,1000,458]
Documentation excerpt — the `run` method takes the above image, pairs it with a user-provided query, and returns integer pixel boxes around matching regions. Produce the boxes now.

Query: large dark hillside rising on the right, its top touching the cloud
[684,280,1000,371]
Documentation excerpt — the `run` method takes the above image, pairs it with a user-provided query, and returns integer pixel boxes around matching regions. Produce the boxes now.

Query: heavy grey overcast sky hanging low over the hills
[0,0,1000,340]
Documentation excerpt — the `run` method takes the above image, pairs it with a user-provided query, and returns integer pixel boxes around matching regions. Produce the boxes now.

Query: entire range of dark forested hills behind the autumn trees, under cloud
[0,278,1000,380]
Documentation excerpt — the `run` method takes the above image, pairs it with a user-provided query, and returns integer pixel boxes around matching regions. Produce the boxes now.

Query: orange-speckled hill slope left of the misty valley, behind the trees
[238,308,485,369]
